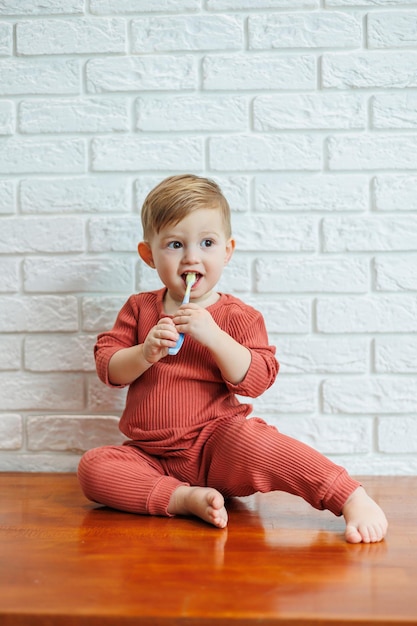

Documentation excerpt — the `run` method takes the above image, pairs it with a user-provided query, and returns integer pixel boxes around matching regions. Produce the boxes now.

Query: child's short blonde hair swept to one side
[141,174,232,241]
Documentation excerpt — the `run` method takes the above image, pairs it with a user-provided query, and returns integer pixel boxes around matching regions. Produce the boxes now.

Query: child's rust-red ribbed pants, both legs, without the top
[78,417,360,515]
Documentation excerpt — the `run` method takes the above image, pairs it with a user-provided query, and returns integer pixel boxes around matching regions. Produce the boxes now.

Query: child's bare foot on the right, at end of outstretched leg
[342,487,388,543]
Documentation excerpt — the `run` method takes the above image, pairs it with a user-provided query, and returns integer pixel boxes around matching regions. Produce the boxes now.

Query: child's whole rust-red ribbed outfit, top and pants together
[78,289,359,515]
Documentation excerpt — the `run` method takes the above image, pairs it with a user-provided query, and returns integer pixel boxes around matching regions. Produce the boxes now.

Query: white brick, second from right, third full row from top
[253,93,366,131]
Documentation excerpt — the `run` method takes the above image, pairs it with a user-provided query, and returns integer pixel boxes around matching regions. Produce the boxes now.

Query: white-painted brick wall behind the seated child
[0,0,417,474]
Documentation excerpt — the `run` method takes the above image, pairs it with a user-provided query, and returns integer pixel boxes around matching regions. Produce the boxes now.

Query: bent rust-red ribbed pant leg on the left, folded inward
[78,445,186,515]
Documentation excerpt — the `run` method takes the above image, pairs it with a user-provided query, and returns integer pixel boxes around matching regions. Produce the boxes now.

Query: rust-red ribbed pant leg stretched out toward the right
[200,417,360,515]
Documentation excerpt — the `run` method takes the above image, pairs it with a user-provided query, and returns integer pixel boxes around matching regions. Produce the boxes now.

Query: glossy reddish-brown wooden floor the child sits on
[0,473,417,626]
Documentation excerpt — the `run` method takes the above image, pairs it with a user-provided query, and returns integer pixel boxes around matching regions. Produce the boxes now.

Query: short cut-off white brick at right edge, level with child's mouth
[375,255,417,291]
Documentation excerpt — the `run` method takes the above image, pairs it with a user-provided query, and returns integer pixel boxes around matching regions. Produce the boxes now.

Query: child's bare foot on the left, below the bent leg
[168,485,227,528]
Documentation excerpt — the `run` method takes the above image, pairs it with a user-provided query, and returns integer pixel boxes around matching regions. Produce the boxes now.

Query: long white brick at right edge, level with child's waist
[323,376,417,414]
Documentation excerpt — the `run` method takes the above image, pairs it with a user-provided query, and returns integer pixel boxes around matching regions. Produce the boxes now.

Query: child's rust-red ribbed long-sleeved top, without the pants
[94,289,278,455]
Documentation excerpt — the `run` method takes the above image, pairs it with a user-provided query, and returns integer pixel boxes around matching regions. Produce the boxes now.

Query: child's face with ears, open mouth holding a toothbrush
[139,208,235,302]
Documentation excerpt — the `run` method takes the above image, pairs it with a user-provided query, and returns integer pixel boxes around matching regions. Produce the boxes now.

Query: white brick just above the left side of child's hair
[91,136,204,172]
